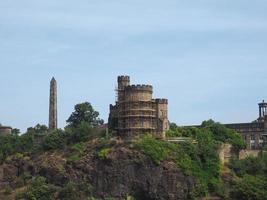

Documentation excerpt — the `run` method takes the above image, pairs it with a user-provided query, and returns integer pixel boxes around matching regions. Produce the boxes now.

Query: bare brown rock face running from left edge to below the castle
[0,143,195,200]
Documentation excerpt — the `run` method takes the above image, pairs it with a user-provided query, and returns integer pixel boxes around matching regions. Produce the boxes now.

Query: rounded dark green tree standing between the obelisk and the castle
[67,102,104,127]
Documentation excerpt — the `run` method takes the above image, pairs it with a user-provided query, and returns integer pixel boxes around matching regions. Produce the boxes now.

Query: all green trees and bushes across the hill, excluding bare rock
[0,111,260,200]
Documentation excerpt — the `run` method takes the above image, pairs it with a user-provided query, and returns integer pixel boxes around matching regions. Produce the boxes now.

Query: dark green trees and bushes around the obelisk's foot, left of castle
[0,102,103,163]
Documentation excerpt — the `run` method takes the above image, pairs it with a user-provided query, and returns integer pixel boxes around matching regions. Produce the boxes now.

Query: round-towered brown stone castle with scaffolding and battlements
[108,76,169,138]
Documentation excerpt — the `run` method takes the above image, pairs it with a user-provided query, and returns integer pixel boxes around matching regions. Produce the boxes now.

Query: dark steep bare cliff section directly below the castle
[81,147,193,200]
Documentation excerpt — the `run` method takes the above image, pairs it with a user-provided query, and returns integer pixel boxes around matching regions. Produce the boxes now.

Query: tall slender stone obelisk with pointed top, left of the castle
[49,77,57,130]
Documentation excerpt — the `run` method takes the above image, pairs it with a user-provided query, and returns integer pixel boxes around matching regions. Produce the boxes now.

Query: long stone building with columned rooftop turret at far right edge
[225,101,267,150]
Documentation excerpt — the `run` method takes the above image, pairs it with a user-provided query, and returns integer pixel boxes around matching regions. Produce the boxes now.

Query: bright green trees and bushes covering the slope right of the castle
[137,120,248,197]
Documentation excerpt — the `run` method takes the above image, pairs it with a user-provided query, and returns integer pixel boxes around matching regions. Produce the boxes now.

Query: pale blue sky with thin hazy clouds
[0,0,267,131]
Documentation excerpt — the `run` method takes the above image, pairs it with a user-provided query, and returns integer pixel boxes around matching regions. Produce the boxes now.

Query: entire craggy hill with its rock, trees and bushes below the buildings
[0,103,267,200]
